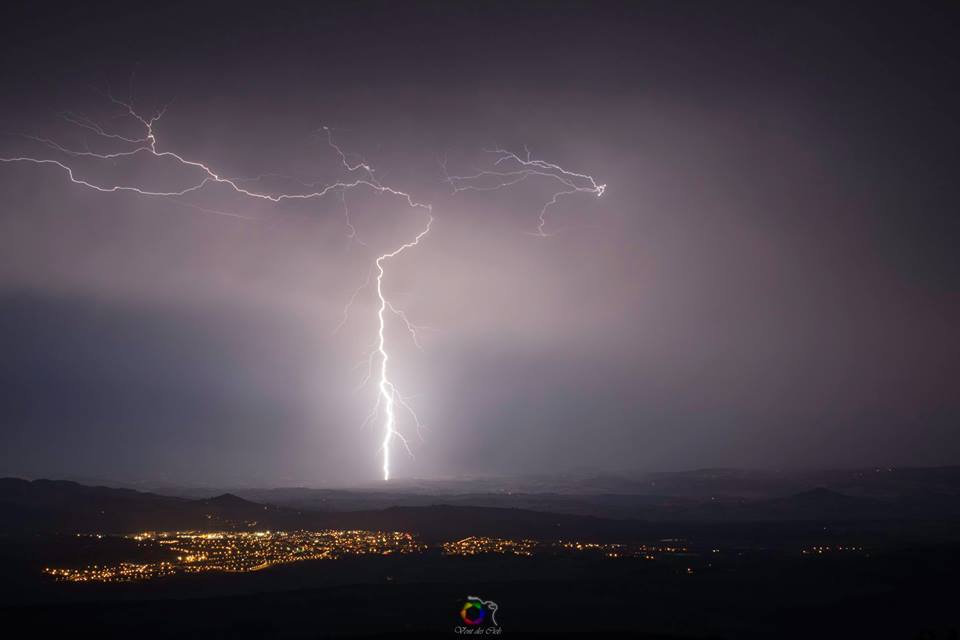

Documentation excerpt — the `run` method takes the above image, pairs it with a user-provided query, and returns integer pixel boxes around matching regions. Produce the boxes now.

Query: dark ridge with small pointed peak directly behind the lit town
[0,478,656,540]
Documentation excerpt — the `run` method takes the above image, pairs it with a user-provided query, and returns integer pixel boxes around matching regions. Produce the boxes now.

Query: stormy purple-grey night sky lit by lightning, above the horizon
[0,2,960,486]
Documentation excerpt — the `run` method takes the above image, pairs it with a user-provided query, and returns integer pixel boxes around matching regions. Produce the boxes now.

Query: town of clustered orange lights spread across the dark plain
[43,530,687,582]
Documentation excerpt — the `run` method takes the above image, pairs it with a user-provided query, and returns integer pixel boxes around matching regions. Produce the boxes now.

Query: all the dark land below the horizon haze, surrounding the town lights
[0,472,960,640]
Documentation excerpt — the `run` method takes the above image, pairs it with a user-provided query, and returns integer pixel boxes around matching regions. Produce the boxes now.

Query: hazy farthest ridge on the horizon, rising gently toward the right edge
[227,467,960,522]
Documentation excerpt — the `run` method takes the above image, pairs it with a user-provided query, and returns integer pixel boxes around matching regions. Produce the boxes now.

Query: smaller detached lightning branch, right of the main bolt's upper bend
[441,146,607,238]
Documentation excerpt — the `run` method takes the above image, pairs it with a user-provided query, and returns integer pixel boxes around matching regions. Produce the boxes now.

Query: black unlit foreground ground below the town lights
[0,546,960,639]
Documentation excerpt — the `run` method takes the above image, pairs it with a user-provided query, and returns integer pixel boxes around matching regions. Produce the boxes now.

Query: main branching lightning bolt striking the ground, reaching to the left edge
[0,94,434,480]
